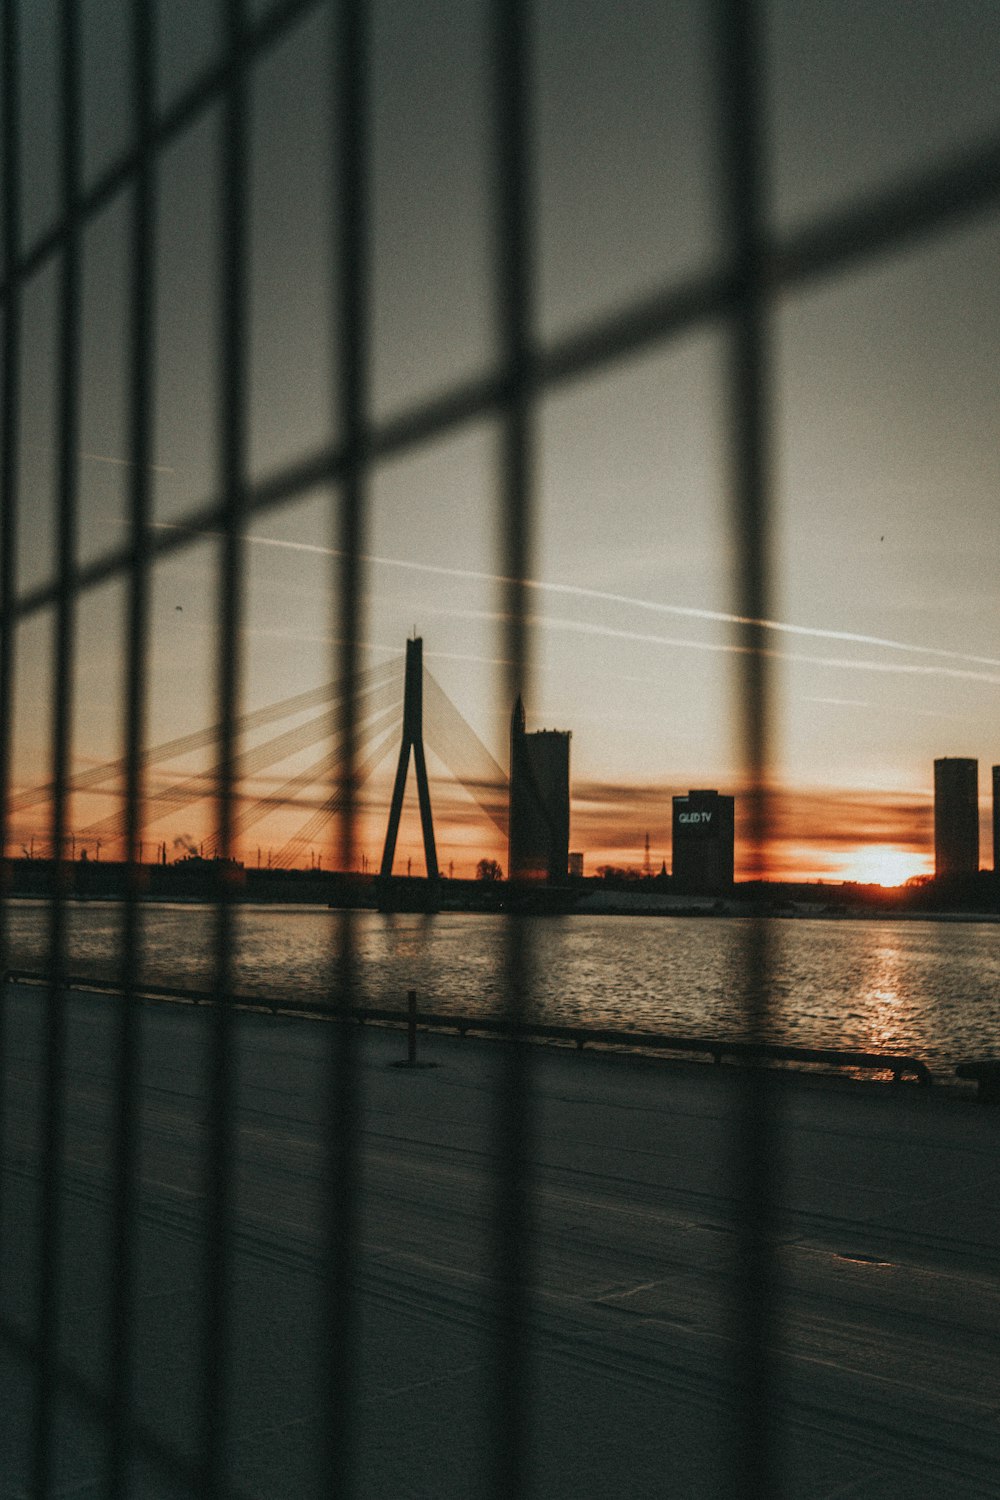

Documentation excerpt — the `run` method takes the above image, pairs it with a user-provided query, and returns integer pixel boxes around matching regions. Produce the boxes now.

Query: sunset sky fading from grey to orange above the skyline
[7,0,1000,881]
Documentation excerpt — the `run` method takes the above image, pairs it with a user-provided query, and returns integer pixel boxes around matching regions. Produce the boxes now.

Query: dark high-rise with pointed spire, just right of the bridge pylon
[507,698,570,884]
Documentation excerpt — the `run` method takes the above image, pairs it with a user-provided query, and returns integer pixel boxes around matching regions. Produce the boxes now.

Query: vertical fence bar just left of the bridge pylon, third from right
[319,0,370,1500]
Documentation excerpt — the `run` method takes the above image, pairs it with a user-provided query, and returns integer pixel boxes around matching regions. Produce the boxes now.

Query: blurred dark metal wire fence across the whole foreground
[0,0,1000,1496]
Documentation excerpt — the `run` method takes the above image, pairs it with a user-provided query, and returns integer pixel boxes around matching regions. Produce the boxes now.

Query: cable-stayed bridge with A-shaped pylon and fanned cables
[9,641,508,873]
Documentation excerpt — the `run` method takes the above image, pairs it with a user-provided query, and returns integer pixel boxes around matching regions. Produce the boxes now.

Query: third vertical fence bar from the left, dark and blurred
[108,0,156,1500]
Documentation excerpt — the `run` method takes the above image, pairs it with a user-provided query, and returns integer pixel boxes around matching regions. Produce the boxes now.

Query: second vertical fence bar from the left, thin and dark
[33,0,81,1500]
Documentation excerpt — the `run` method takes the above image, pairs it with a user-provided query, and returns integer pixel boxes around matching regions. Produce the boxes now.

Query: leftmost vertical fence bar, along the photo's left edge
[0,0,21,1272]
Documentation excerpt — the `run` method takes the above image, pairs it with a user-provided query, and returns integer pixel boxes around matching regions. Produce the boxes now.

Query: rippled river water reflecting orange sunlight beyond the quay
[9,902,1000,1074]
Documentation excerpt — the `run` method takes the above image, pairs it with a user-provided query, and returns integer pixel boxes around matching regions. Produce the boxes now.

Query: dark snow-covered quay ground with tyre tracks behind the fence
[0,992,1000,1500]
